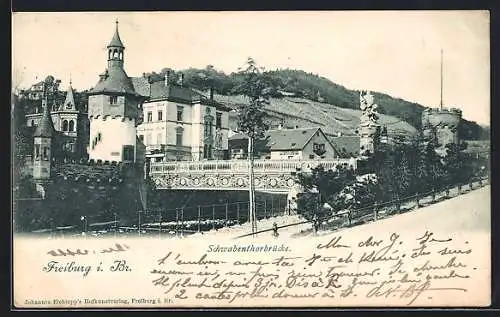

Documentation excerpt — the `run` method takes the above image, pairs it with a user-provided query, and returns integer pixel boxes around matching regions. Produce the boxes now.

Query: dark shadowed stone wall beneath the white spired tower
[14,164,145,232]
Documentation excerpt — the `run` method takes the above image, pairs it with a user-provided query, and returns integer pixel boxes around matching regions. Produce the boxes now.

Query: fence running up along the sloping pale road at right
[235,178,489,239]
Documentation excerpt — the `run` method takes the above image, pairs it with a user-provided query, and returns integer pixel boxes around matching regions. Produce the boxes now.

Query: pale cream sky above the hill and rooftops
[12,11,490,124]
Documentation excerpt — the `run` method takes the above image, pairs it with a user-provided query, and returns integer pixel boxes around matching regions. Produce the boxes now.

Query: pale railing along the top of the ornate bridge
[150,159,357,175]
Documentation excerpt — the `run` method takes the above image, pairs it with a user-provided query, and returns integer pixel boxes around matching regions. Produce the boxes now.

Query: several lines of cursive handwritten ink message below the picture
[149,231,477,306]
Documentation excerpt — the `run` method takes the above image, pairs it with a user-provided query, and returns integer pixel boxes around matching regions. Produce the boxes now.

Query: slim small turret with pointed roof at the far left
[33,83,55,196]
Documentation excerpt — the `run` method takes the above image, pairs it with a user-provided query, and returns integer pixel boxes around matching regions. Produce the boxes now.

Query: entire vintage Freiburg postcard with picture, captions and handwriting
[11,11,491,309]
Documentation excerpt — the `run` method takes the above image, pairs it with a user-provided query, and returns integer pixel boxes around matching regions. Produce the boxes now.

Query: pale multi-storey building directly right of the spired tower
[134,73,230,162]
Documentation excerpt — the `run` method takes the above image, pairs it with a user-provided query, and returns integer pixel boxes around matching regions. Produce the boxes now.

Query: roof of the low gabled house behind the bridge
[229,128,320,151]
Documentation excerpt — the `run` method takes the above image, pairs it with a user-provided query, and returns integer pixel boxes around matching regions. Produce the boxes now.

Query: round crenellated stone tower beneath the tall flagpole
[422,108,462,149]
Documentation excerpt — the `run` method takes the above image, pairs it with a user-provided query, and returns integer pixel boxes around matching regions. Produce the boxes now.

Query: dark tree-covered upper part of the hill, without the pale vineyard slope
[144,65,489,140]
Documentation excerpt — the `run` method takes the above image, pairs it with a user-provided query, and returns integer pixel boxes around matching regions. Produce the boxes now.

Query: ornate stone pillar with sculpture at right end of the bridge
[359,91,380,156]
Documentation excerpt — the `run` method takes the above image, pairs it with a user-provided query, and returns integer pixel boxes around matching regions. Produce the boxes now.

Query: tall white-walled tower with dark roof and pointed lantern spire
[88,21,142,162]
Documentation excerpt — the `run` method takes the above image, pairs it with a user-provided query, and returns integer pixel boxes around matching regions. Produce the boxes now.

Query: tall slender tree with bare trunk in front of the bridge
[234,58,270,232]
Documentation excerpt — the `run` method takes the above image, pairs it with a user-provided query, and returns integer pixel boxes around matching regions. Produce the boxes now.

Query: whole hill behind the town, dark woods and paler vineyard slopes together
[143,65,489,140]
